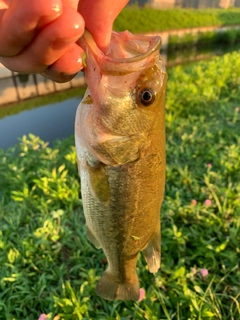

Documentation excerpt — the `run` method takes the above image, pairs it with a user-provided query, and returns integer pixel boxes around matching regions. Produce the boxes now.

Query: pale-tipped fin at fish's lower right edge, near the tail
[143,230,161,273]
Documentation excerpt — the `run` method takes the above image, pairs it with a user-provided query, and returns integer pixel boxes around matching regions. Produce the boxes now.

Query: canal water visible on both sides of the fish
[0,42,240,149]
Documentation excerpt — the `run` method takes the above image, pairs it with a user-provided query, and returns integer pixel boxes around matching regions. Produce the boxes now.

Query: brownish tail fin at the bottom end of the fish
[96,270,140,301]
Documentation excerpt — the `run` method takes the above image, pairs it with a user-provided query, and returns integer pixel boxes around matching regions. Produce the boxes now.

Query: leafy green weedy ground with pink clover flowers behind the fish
[0,53,240,320]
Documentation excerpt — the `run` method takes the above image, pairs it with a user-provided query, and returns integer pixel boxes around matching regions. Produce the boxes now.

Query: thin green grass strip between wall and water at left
[0,88,85,119]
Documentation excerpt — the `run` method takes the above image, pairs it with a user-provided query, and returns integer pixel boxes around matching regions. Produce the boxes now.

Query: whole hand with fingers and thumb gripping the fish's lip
[0,0,128,82]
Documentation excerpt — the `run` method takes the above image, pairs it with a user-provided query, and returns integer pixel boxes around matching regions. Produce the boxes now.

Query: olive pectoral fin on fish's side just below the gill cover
[87,162,110,204]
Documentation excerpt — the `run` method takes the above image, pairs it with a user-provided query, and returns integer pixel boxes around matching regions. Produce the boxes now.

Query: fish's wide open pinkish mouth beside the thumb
[79,30,162,74]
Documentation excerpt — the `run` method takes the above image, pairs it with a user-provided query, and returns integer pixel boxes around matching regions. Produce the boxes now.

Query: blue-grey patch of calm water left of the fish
[0,98,80,149]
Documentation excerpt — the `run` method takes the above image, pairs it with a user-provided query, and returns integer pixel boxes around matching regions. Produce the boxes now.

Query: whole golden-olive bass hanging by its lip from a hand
[75,31,167,301]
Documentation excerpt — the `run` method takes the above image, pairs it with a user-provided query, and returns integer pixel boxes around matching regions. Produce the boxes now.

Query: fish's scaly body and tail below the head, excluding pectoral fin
[80,135,165,300]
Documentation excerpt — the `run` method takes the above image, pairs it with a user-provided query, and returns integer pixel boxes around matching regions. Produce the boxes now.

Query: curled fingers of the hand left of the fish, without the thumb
[0,0,85,82]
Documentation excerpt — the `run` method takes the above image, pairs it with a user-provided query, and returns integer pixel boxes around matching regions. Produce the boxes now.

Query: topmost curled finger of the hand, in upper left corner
[0,0,62,57]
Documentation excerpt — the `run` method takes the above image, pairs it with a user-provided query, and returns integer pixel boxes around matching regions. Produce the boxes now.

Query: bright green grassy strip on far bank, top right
[114,6,240,33]
